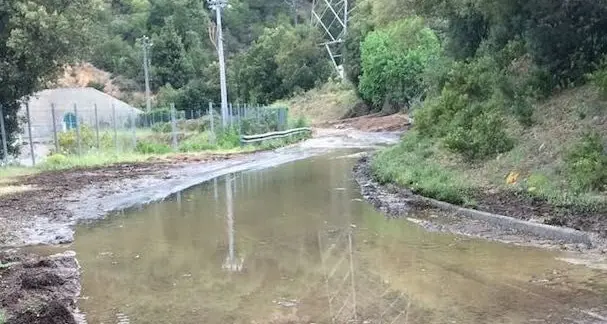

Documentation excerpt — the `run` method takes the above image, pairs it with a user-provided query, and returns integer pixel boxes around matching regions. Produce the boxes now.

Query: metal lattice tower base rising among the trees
[311,0,351,79]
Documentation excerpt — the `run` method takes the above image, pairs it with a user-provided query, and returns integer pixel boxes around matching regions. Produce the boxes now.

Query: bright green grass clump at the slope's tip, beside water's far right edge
[371,131,474,205]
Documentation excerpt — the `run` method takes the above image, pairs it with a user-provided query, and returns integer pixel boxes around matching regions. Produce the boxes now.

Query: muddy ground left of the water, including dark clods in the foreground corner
[0,127,398,324]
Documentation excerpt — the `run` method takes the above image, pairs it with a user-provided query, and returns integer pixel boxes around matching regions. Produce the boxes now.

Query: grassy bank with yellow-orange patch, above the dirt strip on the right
[372,86,607,215]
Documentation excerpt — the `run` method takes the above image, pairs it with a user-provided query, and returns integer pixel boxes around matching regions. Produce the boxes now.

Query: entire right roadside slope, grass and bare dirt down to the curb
[371,86,607,237]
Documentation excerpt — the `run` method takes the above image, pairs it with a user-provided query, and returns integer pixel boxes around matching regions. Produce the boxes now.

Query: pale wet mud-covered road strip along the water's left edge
[0,130,399,247]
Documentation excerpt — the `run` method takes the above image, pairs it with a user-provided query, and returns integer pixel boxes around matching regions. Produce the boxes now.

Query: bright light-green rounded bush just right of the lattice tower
[359,17,441,107]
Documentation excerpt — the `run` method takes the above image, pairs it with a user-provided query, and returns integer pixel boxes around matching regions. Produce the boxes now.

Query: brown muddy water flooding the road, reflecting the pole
[72,153,607,323]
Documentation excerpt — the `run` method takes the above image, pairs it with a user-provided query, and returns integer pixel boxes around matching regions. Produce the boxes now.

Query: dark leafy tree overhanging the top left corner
[0,0,102,157]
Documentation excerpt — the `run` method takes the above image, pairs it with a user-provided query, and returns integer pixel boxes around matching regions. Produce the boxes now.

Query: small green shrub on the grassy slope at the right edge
[565,132,607,191]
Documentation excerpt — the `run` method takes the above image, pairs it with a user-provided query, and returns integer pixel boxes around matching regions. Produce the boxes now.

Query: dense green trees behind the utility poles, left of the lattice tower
[91,0,331,109]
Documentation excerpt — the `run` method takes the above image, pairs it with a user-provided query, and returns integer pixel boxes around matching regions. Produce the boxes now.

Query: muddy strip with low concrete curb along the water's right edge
[354,157,607,254]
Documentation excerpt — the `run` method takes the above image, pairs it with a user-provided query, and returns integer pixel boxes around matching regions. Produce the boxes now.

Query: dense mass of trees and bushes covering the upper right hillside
[345,0,607,166]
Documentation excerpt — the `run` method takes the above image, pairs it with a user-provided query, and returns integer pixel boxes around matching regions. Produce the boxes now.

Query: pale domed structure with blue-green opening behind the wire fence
[20,88,142,143]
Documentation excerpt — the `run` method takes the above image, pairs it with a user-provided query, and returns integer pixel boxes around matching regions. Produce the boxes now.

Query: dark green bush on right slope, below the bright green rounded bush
[415,57,514,160]
